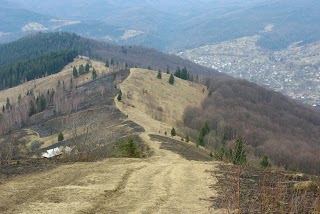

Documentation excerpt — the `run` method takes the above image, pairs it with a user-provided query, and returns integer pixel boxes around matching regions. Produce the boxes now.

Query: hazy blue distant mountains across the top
[0,0,320,52]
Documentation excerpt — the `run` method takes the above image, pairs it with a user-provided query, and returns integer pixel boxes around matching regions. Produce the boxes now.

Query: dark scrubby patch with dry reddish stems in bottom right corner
[213,164,320,214]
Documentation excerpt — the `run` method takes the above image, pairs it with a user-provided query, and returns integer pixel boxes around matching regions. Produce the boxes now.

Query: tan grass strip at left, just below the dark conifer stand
[0,57,109,106]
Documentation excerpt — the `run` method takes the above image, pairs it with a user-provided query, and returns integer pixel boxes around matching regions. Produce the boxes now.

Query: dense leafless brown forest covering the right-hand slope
[184,79,320,173]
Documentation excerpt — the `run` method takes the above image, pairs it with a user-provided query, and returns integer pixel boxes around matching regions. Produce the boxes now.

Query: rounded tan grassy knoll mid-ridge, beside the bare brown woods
[117,68,207,134]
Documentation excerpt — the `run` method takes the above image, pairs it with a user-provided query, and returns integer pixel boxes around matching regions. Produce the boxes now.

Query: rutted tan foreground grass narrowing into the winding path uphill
[0,69,221,214]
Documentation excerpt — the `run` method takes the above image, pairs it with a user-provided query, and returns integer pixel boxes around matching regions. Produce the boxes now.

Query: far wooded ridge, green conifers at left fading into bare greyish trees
[0,33,224,80]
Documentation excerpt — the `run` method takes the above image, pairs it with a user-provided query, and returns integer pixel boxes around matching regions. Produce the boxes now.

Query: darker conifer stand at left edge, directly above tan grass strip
[0,50,78,89]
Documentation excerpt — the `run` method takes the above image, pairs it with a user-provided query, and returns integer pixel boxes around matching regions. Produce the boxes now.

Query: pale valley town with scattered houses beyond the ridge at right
[177,36,320,107]
